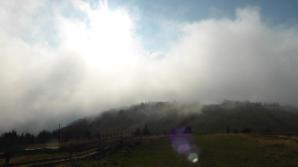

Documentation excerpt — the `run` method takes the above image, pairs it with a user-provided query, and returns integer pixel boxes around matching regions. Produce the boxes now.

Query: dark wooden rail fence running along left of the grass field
[0,133,142,166]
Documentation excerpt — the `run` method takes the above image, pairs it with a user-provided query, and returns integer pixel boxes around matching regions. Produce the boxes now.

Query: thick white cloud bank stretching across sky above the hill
[0,0,298,130]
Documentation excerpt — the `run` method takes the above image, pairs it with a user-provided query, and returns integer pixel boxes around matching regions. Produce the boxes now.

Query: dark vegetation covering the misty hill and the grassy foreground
[0,101,298,167]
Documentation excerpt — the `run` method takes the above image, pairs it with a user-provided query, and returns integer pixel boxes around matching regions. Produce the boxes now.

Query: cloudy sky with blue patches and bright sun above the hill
[0,0,298,132]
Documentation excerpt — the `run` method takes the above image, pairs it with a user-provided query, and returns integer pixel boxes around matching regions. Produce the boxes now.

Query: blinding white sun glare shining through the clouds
[62,0,137,71]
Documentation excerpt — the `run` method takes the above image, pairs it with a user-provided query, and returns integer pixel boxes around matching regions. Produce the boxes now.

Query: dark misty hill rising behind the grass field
[62,101,298,137]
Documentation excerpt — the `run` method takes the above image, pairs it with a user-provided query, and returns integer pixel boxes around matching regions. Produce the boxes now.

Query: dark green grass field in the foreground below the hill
[59,134,298,167]
